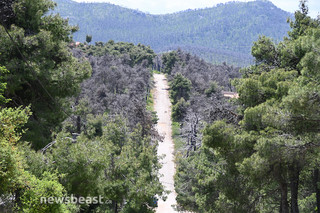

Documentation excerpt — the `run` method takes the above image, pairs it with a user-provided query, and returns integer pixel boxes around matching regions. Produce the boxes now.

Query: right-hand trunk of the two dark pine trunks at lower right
[289,162,300,213]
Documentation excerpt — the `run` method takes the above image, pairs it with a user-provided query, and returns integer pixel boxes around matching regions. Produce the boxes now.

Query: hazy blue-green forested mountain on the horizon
[55,0,293,66]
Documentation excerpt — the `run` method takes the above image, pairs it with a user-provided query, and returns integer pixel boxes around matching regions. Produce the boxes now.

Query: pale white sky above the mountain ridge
[74,0,320,18]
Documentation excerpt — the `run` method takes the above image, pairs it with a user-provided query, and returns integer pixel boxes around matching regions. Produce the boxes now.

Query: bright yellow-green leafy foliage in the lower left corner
[0,102,70,213]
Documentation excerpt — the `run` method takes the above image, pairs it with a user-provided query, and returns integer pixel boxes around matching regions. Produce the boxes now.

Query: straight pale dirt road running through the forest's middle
[154,74,176,213]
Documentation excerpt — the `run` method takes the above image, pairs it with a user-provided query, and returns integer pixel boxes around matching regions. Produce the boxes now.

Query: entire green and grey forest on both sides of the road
[0,0,320,213]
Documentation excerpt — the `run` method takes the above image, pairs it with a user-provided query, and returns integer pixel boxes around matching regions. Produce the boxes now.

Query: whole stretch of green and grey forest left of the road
[0,0,165,213]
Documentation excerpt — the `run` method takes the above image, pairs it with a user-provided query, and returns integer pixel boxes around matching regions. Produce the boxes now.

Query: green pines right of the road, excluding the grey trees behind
[178,1,320,213]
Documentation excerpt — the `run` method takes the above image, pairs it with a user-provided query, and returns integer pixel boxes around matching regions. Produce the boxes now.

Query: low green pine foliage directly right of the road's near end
[175,149,221,212]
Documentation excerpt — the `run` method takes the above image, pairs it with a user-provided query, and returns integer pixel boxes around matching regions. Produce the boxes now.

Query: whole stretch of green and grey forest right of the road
[170,1,320,213]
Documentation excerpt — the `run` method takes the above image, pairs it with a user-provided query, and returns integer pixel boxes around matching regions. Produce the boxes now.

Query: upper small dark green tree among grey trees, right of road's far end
[170,73,192,104]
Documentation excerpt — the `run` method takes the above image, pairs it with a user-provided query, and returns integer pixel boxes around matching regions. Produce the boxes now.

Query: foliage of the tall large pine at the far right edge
[229,2,320,212]
